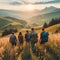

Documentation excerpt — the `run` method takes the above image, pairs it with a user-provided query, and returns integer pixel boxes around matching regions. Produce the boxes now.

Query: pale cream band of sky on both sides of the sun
[0,3,60,11]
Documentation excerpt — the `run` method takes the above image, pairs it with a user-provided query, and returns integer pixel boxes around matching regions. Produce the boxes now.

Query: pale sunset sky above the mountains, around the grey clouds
[0,0,60,11]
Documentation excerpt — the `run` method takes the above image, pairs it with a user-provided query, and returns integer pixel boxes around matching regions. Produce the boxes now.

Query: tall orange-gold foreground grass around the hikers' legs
[0,33,60,60]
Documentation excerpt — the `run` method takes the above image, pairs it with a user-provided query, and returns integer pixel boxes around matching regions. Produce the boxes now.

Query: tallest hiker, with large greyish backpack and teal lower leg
[30,28,38,53]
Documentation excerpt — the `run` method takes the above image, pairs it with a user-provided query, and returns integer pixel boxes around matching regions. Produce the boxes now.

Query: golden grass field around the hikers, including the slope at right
[0,24,60,60]
